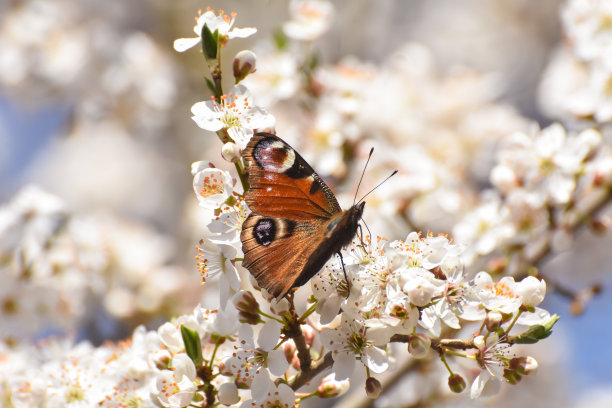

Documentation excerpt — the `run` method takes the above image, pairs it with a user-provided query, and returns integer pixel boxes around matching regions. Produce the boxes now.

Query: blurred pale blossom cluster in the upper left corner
[0,0,177,138]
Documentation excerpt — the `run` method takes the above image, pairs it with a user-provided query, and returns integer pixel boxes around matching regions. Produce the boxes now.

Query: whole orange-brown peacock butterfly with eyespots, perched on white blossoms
[240,132,365,299]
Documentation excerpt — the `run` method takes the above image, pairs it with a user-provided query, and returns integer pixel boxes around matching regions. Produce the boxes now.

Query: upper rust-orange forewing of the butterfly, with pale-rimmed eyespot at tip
[243,132,341,220]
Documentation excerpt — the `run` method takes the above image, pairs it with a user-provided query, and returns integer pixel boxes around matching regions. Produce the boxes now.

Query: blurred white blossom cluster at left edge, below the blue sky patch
[0,185,192,344]
